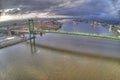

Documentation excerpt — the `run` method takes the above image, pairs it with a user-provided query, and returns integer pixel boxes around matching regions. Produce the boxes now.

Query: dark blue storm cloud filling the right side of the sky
[55,0,119,15]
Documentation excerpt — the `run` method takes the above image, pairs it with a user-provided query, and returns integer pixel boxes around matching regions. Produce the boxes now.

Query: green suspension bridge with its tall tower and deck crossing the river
[28,19,120,41]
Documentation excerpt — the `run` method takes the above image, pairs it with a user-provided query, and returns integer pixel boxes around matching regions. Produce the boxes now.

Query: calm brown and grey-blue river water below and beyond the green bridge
[0,22,120,80]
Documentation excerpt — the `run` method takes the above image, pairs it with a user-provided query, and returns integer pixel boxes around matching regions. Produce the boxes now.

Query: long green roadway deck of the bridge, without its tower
[13,30,120,41]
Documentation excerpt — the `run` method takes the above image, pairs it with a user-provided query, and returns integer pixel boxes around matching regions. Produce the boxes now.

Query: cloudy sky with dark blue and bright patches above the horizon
[0,0,120,19]
